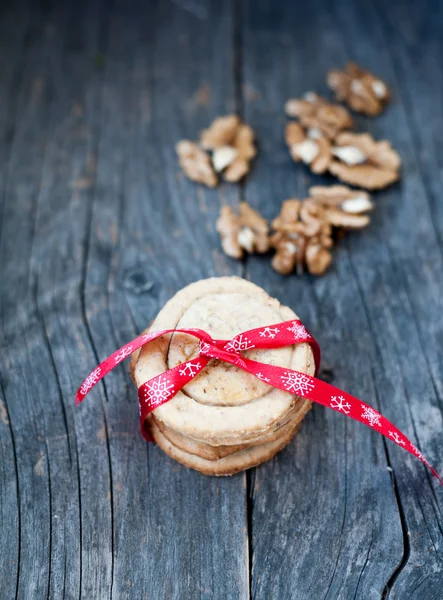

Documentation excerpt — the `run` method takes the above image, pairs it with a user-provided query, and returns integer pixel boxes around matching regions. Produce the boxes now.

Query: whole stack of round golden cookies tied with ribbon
[131,277,315,475]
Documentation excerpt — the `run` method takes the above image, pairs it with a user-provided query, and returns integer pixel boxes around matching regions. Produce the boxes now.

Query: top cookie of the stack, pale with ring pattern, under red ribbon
[134,277,315,445]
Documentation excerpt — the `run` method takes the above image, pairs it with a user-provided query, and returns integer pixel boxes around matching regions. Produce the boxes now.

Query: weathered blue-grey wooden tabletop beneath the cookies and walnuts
[0,0,443,600]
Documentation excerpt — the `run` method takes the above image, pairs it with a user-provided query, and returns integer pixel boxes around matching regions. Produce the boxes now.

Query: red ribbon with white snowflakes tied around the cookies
[75,320,443,485]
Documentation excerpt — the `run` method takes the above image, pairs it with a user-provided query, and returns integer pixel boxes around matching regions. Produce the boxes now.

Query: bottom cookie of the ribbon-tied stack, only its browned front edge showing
[150,414,306,475]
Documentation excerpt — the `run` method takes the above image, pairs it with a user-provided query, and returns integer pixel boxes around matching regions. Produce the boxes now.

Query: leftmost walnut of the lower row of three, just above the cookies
[217,202,270,258]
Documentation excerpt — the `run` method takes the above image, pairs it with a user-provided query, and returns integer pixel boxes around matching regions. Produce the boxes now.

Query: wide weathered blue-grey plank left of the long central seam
[1,3,248,598]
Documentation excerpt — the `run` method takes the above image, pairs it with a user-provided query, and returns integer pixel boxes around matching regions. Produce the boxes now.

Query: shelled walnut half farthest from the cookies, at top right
[327,62,391,117]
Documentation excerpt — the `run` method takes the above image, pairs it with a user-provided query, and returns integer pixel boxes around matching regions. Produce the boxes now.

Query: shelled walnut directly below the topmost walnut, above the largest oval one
[285,92,353,140]
